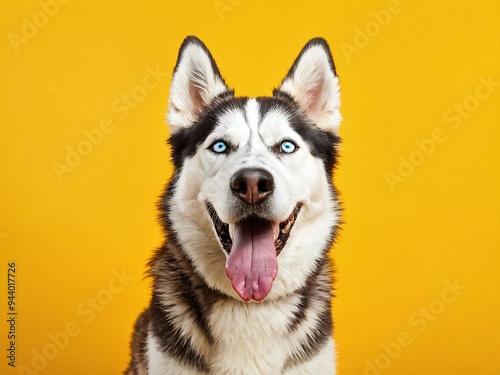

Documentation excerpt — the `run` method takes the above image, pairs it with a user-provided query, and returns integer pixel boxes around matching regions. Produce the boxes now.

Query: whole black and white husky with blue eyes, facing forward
[127,36,341,375]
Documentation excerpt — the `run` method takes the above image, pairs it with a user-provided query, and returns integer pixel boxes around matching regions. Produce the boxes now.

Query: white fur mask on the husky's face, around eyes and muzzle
[171,100,338,299]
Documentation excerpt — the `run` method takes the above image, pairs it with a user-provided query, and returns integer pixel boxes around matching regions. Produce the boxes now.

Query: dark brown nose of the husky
[231,168,274,205]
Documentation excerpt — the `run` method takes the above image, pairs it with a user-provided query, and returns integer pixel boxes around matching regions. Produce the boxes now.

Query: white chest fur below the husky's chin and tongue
[147,296,335,375]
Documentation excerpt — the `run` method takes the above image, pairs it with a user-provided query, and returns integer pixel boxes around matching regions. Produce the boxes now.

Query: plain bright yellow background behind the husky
[0,0,500,375]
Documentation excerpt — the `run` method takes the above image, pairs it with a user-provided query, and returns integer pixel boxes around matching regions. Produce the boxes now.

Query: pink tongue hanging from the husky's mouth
[226,219,278,301]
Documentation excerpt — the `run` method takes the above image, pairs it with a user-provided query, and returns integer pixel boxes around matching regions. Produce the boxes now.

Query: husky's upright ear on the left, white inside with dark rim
[167,36,233,134]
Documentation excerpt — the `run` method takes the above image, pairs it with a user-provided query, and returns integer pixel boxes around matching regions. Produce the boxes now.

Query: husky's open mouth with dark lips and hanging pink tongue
[207,203,302,301]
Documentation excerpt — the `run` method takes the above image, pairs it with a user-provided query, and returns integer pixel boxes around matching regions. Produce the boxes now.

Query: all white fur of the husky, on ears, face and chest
[148,39,341,375]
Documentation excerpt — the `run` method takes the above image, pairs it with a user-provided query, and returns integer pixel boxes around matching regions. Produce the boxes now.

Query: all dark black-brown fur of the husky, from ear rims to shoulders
[127,37,340,375]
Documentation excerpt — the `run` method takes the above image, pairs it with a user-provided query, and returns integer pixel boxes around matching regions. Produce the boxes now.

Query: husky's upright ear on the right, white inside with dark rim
[274,38,342,135]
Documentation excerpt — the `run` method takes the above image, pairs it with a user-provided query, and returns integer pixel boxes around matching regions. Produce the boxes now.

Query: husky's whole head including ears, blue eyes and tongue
[168,37,341,301]
